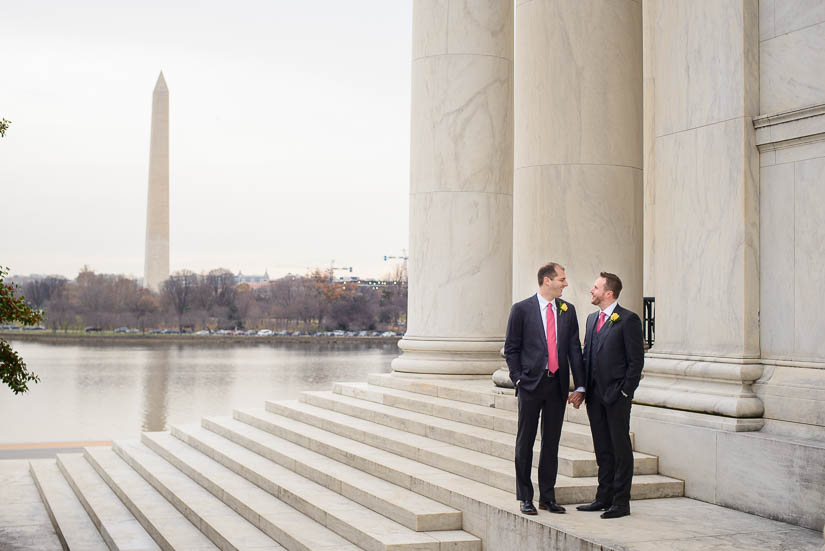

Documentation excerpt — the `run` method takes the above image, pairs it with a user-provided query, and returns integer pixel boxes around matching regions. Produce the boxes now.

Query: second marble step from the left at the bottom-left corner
[57,453,160,551]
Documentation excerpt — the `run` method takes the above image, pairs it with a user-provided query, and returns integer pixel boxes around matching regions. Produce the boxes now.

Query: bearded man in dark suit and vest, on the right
[576,272,645,518]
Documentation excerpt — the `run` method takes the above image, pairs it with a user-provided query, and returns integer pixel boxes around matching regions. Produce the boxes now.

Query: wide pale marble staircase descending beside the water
[17,375,816,551]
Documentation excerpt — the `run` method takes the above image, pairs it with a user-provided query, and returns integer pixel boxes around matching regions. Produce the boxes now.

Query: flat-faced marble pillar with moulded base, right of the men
[635,0,763,430]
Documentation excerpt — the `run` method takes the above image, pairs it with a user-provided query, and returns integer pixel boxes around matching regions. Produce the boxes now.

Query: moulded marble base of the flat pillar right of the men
[633,352,764,430]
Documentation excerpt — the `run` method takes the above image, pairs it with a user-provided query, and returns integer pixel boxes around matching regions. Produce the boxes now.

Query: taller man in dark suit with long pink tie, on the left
[504,262,585,515]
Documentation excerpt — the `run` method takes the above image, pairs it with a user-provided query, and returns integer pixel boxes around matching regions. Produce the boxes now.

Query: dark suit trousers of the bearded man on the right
[587,385,633,506]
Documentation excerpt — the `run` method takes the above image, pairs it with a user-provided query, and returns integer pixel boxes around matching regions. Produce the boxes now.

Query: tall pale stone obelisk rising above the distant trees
[143,71,169,291]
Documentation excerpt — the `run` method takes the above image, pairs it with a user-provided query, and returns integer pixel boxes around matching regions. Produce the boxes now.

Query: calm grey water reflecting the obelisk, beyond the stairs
[0,341,398,444]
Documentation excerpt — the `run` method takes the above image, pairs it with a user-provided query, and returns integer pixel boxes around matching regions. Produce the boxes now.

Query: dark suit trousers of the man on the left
[516,377,567,502]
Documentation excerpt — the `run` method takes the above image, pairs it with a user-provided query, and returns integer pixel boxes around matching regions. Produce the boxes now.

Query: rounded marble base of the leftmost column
[392,336,505,378]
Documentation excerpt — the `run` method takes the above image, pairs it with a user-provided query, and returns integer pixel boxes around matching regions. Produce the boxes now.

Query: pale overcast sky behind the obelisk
[0,0,412,277]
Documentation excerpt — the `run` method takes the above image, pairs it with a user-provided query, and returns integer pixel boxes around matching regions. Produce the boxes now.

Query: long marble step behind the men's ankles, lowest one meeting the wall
[249,401,684,503]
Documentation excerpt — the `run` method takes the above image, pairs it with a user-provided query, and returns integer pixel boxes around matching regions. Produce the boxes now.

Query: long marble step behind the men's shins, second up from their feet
[300,386,658,478]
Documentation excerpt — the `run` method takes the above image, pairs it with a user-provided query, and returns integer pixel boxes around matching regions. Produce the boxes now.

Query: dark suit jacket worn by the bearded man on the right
[584,304,645,404]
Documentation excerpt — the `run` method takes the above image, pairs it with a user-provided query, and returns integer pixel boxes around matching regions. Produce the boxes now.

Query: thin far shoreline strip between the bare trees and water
[0,331,401,345]
